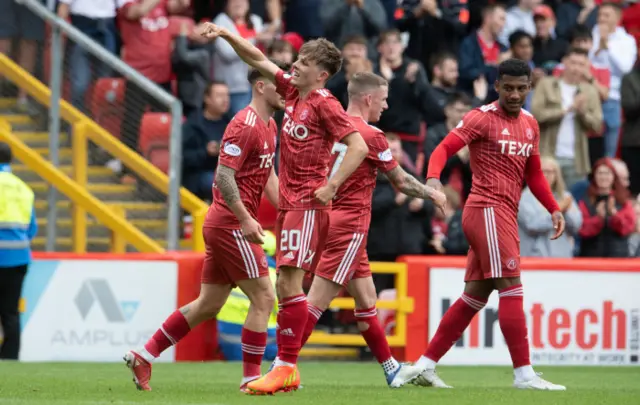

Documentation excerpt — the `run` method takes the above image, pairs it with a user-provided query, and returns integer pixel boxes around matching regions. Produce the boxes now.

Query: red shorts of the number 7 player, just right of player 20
[315,215,371,287]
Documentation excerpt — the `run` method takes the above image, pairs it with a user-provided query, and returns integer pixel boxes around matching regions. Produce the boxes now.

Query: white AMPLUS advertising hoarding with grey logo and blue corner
[20,260,178,361]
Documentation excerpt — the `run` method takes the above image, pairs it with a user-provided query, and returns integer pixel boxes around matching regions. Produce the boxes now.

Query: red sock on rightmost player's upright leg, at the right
[498,284,531,368]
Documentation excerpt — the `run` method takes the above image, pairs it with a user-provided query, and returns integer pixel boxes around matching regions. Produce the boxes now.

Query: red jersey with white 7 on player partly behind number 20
[331,117,398,232]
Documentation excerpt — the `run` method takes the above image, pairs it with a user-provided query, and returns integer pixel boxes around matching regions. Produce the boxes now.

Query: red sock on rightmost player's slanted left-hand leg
[424,294,487,363]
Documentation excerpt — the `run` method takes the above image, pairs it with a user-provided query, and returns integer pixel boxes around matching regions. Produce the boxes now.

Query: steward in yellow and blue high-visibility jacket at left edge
[0,142,38,361]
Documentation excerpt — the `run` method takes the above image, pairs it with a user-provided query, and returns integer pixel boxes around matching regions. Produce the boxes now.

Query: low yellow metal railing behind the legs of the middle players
[309,262,413,347]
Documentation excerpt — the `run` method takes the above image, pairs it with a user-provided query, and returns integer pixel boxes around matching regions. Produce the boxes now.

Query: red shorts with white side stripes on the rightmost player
[462,207,520,281]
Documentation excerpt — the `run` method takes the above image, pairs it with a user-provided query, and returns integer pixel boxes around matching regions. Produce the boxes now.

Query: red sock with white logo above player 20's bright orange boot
[278,294,308,364]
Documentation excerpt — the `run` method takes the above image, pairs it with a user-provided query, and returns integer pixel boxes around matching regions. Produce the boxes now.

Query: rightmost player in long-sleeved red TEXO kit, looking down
[416,59,565,391]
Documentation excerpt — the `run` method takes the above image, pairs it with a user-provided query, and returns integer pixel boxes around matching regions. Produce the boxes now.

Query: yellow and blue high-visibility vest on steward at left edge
[0,171,35,249]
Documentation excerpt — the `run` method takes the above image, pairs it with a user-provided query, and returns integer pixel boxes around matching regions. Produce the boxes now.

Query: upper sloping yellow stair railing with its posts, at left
[0,54,208,253]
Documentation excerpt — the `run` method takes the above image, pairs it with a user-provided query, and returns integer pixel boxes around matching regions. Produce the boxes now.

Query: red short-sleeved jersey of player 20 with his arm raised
[276,71,356,210]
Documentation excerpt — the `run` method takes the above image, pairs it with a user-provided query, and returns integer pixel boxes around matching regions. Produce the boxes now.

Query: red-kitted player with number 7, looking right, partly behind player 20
[290,73,445,388]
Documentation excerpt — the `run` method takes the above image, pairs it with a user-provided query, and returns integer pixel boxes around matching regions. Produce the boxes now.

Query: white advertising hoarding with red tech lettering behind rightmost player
[429,268,640,365]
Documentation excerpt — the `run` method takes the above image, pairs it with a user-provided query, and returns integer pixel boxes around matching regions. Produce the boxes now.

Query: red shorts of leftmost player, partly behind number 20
[202,227,269,286]
